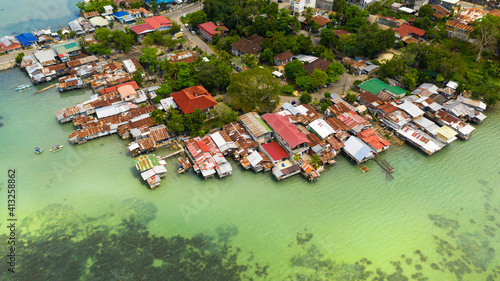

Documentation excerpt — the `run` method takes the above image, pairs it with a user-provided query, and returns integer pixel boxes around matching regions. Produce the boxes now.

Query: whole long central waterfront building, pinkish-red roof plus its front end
[262,113,309,155]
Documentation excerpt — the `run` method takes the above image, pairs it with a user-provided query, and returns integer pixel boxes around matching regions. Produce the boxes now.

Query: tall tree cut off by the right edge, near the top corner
[471,14,500,61]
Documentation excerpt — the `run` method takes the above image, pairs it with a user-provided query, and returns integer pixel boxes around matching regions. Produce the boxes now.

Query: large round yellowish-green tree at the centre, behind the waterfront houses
[228,67,280,112]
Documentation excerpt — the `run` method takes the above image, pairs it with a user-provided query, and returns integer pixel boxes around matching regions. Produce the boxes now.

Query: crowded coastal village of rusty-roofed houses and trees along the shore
[0,0,500,189]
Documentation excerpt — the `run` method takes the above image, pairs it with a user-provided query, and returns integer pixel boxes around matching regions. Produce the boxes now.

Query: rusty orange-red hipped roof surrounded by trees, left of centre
[172,86,217,114]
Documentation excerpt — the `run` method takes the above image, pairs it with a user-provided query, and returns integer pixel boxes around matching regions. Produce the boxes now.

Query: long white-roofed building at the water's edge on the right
[396,124,445,155]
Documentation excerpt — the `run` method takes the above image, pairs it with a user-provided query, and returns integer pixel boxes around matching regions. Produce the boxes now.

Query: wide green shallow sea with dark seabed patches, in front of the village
[0,66,500,280]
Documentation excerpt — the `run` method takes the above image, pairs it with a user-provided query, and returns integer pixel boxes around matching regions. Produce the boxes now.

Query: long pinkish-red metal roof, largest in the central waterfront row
[262,113,309,149]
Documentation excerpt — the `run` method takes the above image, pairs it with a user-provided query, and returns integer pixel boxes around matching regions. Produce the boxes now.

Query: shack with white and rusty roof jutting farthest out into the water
[134,154,167,189]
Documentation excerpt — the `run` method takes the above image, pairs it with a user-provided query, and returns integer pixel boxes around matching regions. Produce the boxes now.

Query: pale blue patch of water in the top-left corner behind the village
[0,0,78,37]
